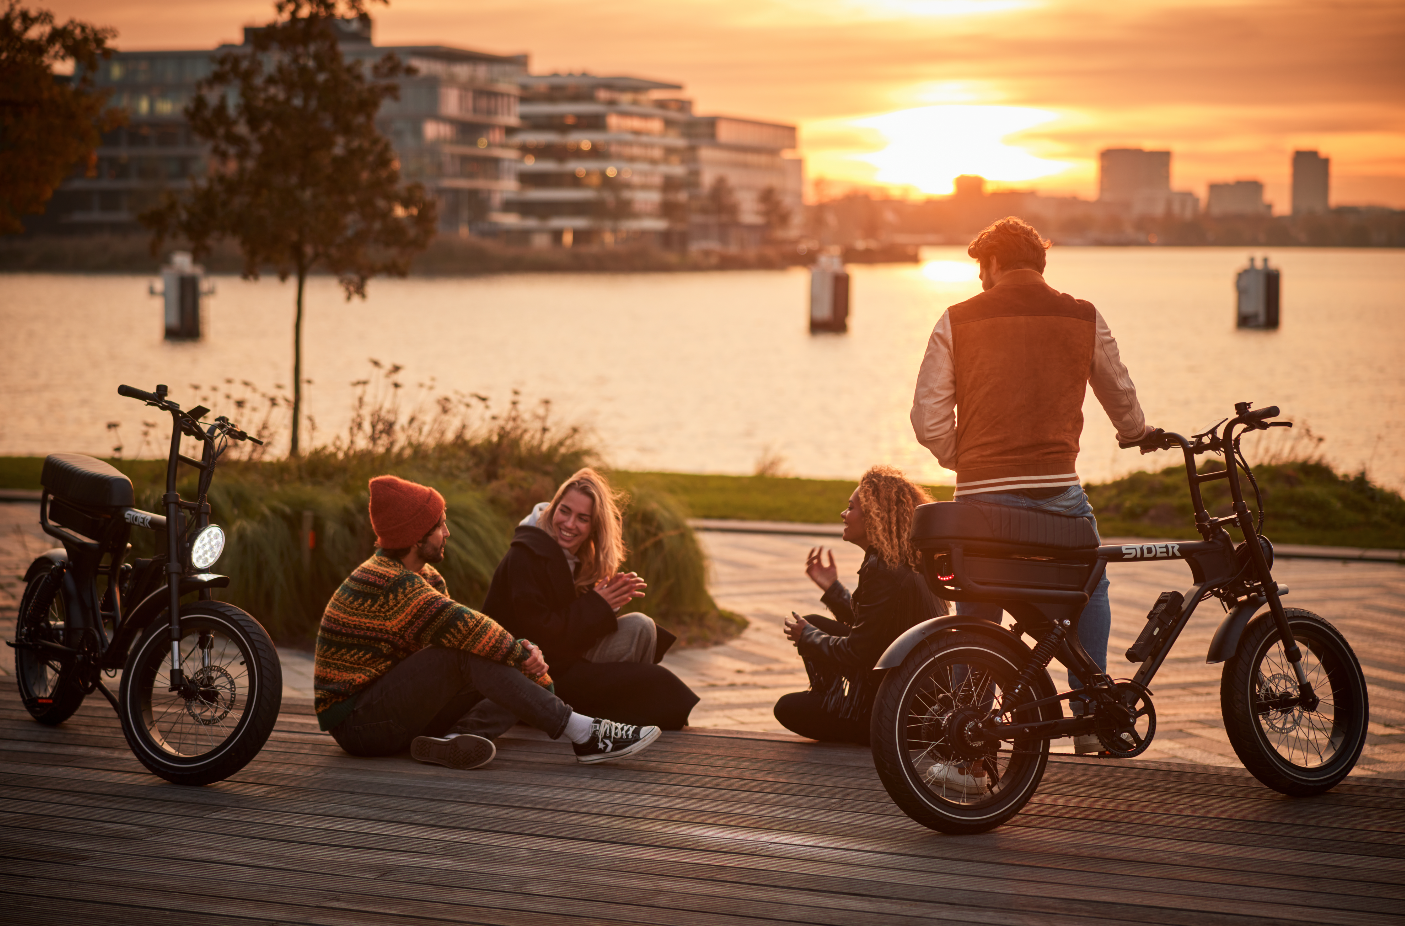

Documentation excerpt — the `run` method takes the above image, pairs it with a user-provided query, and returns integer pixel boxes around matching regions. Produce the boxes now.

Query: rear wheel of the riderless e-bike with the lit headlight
[14,569,84,726]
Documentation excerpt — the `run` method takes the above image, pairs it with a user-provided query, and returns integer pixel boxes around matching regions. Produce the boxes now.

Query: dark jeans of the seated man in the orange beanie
[332,646,570,756]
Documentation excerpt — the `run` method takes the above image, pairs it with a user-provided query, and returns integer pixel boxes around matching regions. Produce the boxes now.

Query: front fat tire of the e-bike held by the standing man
[1220,608,1370,797]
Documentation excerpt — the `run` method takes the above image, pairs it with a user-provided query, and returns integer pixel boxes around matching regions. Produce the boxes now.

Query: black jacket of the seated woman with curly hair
[803,549,946,682]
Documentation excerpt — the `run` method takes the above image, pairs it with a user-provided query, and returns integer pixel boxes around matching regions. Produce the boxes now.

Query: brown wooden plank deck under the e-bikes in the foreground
[0,684,1405,926]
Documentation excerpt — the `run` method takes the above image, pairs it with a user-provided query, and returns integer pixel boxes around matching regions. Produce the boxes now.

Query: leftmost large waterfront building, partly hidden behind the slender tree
[27,20,527,233]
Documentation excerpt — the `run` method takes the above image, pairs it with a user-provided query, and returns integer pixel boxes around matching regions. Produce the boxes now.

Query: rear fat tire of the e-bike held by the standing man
[870,631,1058,835]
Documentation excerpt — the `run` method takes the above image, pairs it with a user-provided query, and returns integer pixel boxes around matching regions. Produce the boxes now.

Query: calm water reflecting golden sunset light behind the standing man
[0,247,1405,486]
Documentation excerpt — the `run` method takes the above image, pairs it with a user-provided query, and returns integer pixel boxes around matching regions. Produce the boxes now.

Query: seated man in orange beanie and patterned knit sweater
[313,476,659,769]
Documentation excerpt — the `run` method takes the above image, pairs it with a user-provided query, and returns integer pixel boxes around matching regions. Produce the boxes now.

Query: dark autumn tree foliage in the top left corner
[0,0,125,235]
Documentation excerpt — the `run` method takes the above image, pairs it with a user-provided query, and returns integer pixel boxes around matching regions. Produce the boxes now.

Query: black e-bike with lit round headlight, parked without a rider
[10,386,282,784]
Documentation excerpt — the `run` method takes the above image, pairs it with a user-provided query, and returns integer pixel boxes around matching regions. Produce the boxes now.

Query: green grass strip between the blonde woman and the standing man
[610,471,951,524]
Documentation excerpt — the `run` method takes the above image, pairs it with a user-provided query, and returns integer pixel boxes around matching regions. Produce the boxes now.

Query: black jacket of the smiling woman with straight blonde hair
[483,526,615,676]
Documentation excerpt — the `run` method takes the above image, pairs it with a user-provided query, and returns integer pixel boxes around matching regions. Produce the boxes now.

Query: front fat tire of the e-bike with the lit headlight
[118,601,282,785]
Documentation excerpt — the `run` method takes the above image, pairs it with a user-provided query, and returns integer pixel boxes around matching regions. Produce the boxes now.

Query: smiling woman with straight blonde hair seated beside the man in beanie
[473,468,698,738]
